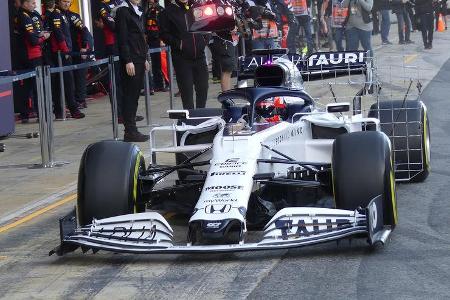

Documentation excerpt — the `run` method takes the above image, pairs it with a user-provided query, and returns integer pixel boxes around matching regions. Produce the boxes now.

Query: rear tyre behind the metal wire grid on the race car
[369,100,431,182]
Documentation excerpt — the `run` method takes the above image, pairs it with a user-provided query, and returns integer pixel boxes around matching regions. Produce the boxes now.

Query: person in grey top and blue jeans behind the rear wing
[344,0,373,57]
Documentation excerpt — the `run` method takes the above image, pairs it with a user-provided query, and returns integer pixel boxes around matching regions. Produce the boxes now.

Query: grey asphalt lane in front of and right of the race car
[0,35,450,299]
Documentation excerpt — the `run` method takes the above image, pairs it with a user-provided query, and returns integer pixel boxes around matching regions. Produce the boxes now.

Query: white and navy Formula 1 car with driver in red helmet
[50,50,430,255]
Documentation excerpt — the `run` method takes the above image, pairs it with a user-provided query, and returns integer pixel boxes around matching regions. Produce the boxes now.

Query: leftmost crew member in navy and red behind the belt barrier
[15,0,50,123]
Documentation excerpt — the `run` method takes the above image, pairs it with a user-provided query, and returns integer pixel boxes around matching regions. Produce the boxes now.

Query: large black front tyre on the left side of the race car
[77,141,145,226]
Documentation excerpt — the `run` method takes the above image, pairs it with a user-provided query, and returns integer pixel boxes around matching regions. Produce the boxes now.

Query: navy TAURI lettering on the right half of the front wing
[275,219,350,240]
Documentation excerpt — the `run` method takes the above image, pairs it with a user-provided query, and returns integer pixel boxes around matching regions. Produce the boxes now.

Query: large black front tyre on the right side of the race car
[332,131,398,226]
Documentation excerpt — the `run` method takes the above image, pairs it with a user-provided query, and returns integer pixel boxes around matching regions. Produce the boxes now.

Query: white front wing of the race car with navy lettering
[50,196,391,255]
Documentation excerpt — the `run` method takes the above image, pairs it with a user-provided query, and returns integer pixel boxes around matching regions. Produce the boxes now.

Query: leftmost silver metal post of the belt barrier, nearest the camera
[36,66,51,168]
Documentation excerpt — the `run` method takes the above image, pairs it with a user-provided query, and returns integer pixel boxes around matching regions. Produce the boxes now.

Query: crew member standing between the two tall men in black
[145,0,168,92]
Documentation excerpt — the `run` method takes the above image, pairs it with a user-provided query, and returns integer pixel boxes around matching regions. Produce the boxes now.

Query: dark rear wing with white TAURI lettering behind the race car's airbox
[238,49,372,81]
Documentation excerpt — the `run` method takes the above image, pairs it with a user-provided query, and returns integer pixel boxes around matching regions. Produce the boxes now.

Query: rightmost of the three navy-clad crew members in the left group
[65,10,94,109]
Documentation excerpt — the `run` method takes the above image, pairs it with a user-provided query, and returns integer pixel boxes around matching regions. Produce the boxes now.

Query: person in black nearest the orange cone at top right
[415,0,434,49]
